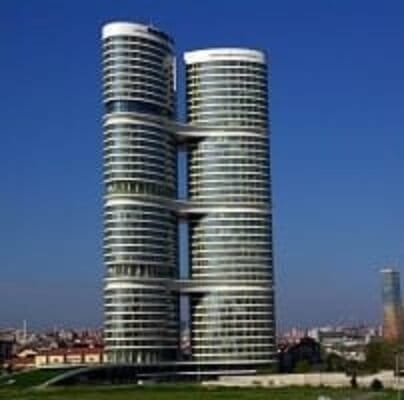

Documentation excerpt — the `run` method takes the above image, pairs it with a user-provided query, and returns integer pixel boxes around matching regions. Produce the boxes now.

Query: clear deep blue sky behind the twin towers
[0,0,404,327]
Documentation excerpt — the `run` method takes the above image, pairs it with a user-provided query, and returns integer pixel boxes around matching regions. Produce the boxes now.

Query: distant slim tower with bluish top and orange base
[380,268,403,341]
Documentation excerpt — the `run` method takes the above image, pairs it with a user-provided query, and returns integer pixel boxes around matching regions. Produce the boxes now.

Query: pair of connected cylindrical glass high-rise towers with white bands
[102,22,276,371]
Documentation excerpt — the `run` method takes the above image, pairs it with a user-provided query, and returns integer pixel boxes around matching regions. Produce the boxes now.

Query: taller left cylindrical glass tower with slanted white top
[102,22,178,363]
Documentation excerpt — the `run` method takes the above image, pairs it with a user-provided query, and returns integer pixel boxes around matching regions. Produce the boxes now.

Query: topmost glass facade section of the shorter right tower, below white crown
[187,59,268,129]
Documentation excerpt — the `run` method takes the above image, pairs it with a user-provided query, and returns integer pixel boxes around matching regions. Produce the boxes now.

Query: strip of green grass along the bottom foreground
[0,384,397,400]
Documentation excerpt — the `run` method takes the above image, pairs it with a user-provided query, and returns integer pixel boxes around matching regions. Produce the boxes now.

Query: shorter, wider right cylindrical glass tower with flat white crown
[185,48,275,368]
